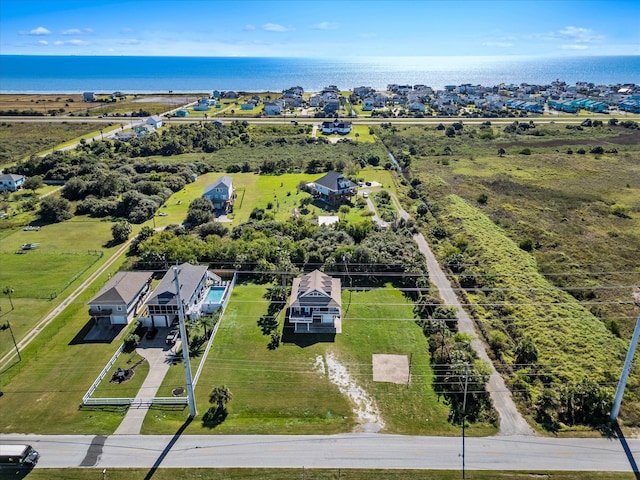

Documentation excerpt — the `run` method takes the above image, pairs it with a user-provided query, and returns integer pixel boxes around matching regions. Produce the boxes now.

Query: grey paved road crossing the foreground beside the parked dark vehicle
[0,433,640,472]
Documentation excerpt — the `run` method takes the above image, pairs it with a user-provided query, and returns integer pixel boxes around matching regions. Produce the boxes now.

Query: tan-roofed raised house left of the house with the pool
[88,272,151,325]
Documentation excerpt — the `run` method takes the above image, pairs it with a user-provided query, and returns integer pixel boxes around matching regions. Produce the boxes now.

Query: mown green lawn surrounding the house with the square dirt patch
[143,284,495,435]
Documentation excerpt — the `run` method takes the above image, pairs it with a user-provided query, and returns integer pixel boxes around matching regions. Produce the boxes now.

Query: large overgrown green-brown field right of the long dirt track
[380,120,640,423]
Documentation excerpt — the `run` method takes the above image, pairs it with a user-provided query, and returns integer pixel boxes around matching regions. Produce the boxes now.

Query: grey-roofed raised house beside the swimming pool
[141,263,221,327]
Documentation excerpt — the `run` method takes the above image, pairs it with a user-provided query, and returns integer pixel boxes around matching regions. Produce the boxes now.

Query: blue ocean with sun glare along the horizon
[0,55,640,93]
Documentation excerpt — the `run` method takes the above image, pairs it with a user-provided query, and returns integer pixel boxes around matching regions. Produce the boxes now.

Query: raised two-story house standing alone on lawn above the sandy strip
[289,270,342,333]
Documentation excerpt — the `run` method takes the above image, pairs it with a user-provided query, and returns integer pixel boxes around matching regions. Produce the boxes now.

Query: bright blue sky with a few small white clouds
[0,0,640,57]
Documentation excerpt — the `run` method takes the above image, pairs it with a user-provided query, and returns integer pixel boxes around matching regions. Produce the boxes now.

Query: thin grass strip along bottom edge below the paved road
[11,468,632,480]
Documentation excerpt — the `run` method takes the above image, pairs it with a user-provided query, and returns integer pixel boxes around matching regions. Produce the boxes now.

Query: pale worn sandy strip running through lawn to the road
[314,353,384,433]
